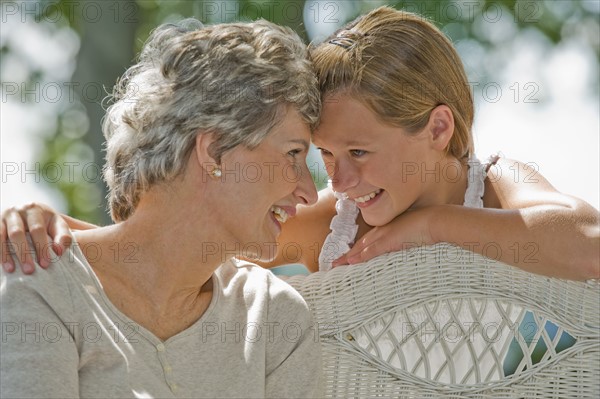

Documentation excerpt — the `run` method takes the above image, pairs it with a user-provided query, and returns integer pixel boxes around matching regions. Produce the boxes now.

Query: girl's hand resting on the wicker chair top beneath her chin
[332,207,437,267]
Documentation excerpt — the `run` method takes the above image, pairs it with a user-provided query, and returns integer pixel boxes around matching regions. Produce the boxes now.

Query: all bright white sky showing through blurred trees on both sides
[0,2,600,216]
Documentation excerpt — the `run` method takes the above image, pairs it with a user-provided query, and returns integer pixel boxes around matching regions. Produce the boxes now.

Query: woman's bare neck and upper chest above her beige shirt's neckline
[75,203,224,340]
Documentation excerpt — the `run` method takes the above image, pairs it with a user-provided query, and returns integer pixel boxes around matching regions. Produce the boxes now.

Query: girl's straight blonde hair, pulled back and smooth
[310,7,474,159]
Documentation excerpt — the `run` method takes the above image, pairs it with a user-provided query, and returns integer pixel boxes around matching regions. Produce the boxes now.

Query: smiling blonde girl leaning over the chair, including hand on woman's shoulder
[2,7,600,280]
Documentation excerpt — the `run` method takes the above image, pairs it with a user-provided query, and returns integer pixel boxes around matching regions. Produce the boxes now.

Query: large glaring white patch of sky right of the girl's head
[474,38,600,209]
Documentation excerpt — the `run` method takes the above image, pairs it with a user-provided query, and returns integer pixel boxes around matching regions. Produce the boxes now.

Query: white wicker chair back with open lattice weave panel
[287,244,600,398]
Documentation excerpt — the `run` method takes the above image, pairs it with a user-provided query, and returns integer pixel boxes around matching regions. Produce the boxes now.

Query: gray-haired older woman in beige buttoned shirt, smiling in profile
[0,21,320,398]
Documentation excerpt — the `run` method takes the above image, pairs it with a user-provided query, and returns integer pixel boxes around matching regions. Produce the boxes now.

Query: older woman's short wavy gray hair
[103,19,321,221]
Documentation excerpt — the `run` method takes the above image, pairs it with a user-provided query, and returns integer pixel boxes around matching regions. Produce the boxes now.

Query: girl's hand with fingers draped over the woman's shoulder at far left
[0,203,73,274]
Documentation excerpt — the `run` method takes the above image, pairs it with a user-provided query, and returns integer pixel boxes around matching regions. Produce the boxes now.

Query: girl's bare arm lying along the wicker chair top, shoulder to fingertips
[336,159,600,280]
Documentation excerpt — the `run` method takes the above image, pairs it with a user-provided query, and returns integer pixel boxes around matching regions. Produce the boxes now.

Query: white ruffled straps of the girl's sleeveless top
[319,155,499,271]
